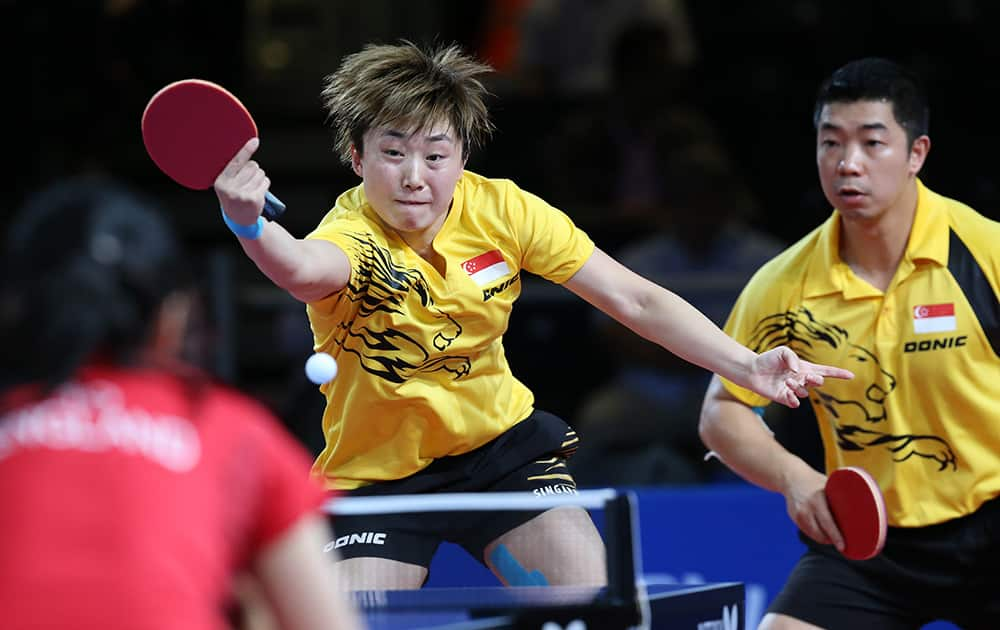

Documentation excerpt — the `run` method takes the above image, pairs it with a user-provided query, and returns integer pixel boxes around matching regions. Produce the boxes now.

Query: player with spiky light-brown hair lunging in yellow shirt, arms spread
[215,43,849,588]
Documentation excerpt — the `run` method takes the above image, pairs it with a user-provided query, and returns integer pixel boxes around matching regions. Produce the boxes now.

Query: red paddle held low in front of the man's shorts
[826,466,887,560]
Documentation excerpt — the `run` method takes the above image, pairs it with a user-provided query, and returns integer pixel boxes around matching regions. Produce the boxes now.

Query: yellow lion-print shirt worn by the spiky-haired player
[296,172,594,489]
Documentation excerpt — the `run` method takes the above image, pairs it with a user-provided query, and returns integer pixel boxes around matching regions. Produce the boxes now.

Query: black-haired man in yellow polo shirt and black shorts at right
[701,58,1000,630]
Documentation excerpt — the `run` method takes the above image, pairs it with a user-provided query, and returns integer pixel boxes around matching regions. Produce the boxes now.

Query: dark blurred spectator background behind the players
[13,0,1000,483]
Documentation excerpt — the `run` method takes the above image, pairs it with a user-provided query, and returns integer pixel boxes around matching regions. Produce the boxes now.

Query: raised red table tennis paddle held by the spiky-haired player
[142,79,285,219]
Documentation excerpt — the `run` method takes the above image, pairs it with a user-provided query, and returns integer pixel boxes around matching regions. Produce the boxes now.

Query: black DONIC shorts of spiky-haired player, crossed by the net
[325,410,578,568]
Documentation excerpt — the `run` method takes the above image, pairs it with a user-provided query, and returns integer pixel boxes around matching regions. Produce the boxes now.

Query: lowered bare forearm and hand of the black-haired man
[698,376,844,549]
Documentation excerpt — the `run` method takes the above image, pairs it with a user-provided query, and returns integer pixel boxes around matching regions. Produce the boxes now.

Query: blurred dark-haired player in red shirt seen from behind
[0,180,358,630]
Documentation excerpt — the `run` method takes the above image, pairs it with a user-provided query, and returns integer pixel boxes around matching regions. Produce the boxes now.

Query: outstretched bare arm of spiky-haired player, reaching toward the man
[565,249,853,407]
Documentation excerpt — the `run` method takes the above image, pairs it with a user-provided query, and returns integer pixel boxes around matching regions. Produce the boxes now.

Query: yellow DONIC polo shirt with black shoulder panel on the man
[725,180,1000,527]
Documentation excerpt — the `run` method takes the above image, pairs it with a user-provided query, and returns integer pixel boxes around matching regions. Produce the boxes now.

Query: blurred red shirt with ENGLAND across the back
[0,368,325,630]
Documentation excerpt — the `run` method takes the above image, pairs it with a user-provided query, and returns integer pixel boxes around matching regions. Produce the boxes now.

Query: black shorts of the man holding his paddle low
[768,499,1000,630]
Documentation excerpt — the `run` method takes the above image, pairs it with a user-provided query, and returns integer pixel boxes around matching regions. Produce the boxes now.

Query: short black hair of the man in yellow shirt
[813,57,930,144]
